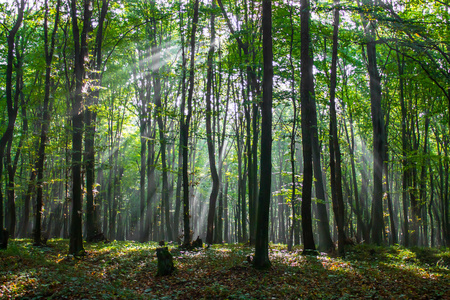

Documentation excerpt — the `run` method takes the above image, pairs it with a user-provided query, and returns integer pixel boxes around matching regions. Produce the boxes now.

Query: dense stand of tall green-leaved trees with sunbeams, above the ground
[0,0,450,254]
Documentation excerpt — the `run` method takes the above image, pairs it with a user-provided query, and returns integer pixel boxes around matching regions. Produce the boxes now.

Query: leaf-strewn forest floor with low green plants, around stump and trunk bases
[0,239,450,299]
